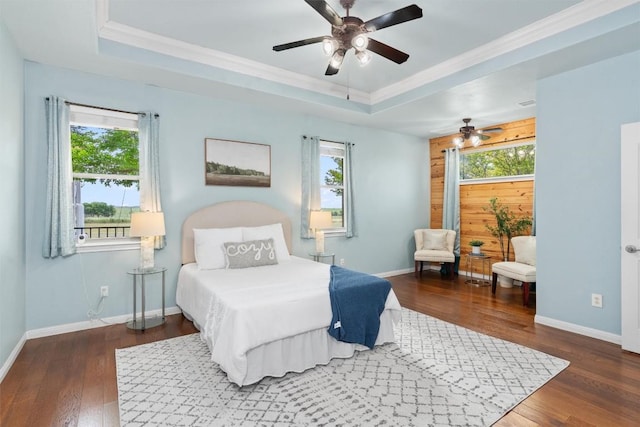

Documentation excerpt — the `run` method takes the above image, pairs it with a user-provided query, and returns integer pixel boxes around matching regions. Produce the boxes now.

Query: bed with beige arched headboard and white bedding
[176,201,400,386]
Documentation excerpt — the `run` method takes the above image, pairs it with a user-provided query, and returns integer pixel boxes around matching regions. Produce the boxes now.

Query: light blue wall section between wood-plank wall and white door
[536,52,640,335]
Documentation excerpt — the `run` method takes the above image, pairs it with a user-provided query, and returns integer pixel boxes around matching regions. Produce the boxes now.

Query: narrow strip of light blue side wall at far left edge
[0,21,26,367]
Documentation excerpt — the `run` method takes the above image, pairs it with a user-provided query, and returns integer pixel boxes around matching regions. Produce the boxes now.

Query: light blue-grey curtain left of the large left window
[42,96,76,258]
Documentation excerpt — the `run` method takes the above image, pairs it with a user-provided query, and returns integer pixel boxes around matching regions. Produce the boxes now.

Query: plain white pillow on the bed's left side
[193,227,242,270]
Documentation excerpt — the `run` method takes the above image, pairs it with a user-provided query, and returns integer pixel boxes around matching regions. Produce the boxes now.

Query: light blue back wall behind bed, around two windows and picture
[25,62,429,330]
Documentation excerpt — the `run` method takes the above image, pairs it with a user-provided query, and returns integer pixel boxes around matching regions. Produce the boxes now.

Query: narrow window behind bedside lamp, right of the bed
[319,140,346,233]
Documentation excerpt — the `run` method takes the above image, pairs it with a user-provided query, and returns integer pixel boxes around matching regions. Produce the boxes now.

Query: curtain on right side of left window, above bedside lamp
[138,112,166,249]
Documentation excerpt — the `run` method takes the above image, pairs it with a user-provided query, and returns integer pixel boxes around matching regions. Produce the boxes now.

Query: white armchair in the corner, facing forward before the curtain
[413,228,456,279]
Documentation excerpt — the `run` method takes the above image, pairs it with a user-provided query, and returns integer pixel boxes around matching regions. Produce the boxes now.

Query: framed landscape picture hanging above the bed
[204,138,271,187]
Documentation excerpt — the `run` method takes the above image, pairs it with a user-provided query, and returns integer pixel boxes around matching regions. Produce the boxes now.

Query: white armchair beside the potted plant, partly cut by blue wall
[491,236,536,306]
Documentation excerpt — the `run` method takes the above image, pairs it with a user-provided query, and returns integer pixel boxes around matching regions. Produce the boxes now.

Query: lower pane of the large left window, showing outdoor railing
[73,180,140,240]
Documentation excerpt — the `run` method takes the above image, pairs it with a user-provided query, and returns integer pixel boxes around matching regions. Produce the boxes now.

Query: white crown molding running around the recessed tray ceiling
[96,0,638,106]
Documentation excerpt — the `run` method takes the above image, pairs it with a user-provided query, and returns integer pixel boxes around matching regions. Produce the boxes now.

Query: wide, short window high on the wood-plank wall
[460,142,536,181]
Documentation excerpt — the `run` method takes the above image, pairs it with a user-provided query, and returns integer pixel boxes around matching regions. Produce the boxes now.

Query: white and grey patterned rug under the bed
[116,308,569,427]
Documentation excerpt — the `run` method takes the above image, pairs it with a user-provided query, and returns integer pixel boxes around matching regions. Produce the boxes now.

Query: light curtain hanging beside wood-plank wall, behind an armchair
[442,148,460,256]
